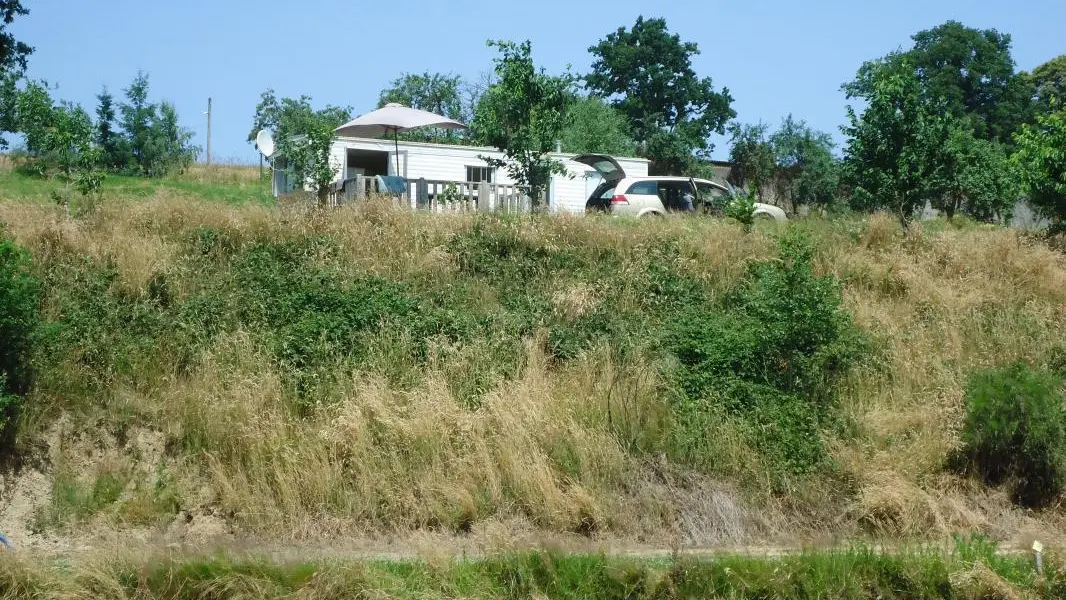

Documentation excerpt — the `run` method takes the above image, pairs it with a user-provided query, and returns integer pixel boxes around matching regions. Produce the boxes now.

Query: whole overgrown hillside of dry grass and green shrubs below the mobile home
[0,166,1066,558]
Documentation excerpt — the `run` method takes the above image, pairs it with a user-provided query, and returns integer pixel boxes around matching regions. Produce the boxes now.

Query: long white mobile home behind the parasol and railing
[274,137,648,213]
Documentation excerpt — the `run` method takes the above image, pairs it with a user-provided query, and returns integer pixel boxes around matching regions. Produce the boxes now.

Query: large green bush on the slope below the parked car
[665,234,862,477]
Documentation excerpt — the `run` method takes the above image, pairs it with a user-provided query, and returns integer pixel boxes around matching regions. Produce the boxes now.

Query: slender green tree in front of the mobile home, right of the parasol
[472,40,572,208]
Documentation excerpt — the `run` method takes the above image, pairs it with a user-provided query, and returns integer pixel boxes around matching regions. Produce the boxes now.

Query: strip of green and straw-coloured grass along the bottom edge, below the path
[0,539,1066,600]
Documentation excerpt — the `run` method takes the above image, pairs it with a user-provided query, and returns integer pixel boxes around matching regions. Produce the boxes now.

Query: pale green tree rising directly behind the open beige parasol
[377,72,469,144]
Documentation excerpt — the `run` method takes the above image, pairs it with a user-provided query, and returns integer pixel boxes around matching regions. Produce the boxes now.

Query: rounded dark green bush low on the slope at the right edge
[963,362,1066,507]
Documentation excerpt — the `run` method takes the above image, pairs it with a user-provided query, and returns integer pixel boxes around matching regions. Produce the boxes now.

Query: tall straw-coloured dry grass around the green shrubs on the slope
[0,192,1066,544]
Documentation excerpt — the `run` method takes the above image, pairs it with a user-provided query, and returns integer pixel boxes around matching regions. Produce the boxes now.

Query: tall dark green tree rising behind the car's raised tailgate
[585,16,737,174]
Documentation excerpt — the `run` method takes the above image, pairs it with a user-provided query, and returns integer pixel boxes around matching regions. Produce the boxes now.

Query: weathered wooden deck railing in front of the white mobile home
[329,176,532,213]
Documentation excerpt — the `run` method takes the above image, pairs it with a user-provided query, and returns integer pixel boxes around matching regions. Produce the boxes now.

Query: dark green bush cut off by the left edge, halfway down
[0,230,41,437]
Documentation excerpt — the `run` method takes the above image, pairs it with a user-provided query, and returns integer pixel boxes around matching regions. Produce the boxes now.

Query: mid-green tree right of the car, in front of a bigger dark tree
[842,55,951,224]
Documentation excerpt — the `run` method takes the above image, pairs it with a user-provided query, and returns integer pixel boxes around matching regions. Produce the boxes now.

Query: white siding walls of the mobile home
[330,139,648,214]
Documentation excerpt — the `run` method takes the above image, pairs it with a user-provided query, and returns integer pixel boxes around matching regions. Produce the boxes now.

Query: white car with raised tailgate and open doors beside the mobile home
[574,155,788,223]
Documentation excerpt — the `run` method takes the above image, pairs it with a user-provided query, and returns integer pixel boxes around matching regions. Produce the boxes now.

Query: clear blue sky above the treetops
[12,0,1066,162]
